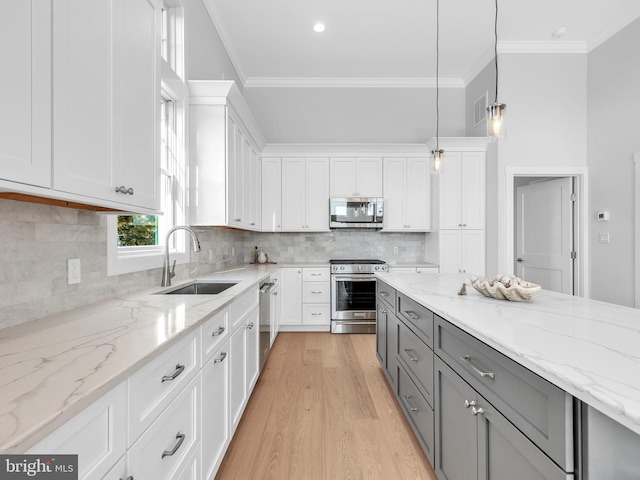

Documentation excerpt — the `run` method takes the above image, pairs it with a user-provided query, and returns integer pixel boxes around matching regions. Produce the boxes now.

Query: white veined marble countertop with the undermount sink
[0,264,279,453]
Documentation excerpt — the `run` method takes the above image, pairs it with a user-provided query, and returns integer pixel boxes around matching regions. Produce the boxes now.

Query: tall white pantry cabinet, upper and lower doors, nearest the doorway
[425,137,488,275]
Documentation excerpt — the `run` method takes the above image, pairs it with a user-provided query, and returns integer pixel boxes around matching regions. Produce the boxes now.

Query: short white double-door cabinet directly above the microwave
[330,157,382,197]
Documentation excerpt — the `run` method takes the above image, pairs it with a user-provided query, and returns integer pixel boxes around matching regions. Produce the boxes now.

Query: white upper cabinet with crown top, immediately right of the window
[189,80,265,231]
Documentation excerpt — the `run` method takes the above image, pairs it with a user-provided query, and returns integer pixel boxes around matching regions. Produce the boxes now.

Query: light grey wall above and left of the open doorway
[487,54,587,271]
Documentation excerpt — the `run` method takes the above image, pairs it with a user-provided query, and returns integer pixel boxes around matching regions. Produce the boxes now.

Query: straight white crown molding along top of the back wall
[244,77,465,88]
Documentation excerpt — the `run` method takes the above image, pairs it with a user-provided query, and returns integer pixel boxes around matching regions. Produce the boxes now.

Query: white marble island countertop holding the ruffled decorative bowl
[376,273,640,434]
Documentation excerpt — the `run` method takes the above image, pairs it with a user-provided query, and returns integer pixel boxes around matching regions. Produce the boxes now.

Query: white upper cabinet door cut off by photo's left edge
[0,0,51,187]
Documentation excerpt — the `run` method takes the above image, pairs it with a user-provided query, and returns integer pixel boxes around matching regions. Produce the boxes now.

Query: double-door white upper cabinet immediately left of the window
[53,0,160,210]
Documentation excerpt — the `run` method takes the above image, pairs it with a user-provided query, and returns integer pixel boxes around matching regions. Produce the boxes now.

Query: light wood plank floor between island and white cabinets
[216,332,436,480]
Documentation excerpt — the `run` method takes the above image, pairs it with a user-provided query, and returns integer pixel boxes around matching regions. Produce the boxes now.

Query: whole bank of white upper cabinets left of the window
[0,0,161,213]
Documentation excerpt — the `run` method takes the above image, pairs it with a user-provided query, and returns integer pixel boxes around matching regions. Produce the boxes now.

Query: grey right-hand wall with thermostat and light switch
[587,20,640,306]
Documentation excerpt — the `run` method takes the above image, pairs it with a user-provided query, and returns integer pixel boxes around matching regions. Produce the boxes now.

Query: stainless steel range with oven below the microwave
[329,259,389,333]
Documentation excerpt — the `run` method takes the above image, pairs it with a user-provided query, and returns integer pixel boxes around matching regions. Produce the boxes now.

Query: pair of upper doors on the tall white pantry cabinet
[439,151,485,229]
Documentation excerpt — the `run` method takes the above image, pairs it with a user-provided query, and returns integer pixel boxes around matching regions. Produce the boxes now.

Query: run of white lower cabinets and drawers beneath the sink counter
[26,288,260,480]
